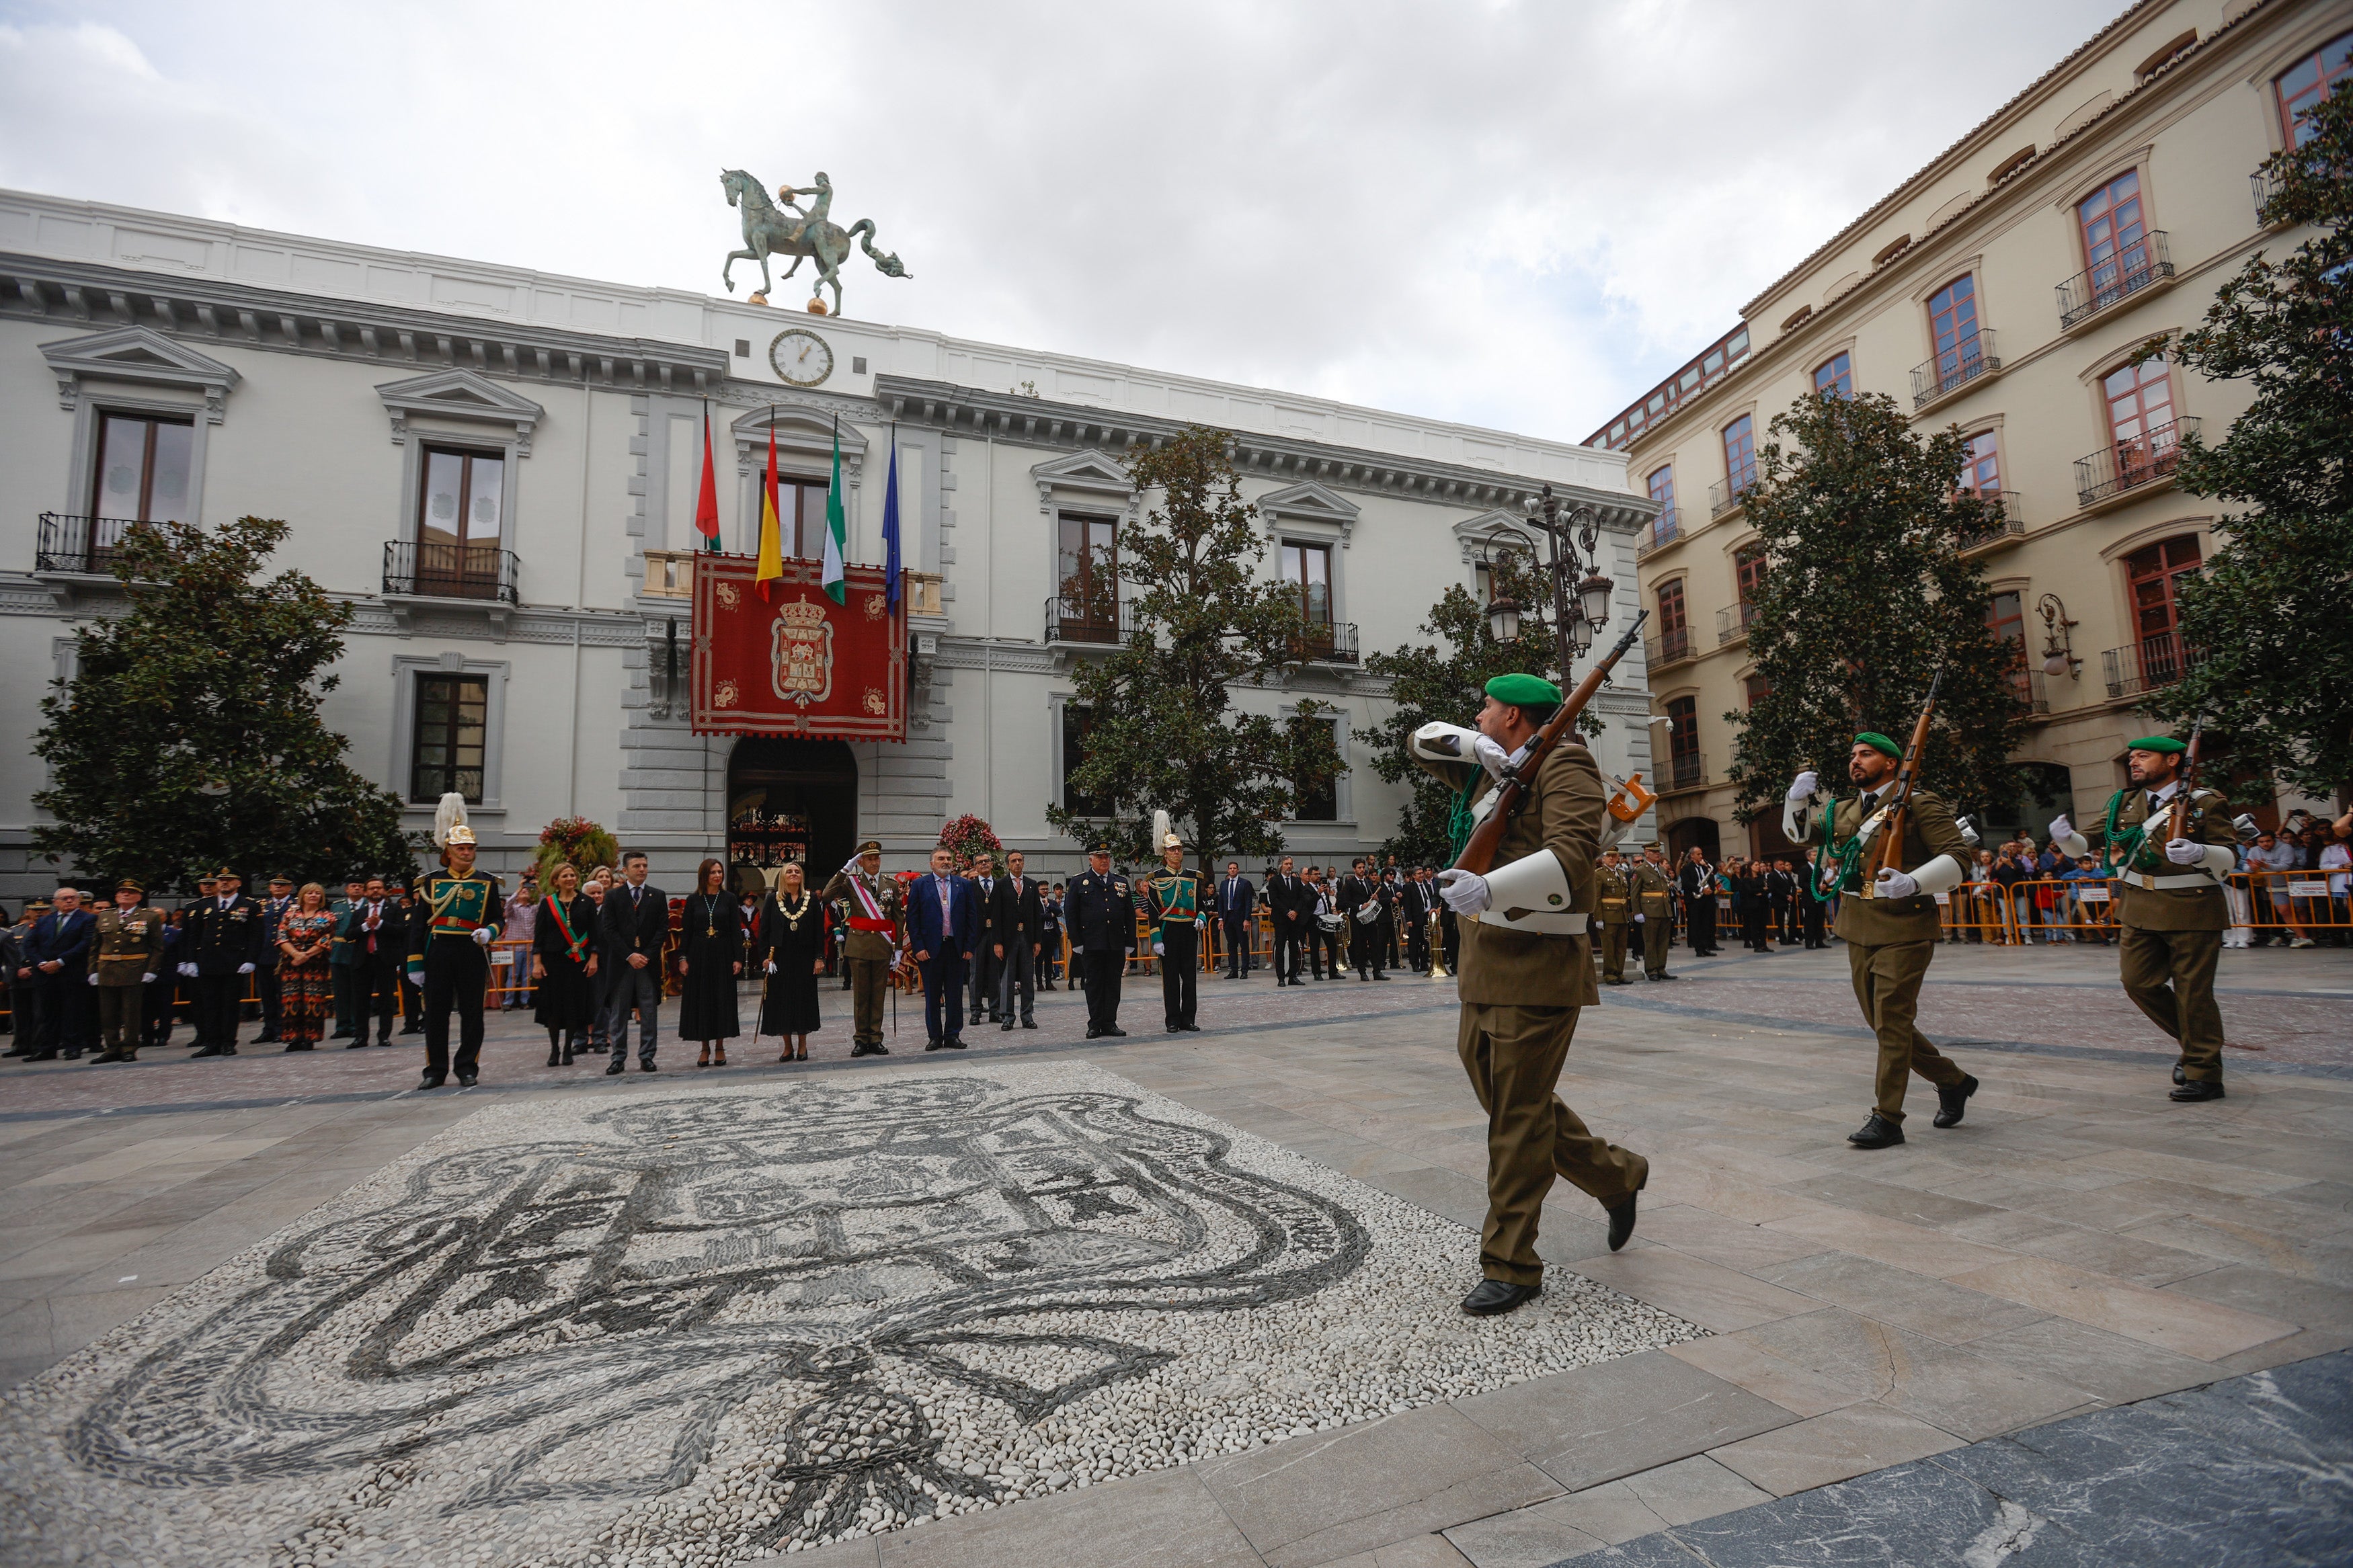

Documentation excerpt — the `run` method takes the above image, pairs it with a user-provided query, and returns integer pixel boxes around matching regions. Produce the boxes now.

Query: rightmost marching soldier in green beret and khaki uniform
[2052,736,2238,1100]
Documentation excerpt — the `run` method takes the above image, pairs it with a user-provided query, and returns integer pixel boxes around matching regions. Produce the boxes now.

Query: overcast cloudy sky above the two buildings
[0,0,2122,440]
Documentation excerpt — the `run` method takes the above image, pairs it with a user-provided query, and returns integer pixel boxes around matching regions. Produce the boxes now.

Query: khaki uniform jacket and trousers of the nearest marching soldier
[1424,743,1650,1286]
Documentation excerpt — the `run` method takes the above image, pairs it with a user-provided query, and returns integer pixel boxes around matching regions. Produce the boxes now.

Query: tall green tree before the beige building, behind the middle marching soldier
[1725,393,2026,823]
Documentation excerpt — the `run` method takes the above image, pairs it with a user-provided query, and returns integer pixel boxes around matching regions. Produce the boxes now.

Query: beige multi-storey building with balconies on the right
[1589,0,2353,856]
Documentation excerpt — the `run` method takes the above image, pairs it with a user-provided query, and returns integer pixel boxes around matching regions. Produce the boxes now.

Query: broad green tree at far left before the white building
[33,518,422,891]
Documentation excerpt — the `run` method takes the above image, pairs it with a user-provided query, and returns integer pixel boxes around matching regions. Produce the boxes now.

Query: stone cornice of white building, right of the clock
[875,376,1659,534]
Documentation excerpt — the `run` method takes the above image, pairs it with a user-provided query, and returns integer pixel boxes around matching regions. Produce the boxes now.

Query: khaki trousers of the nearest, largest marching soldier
[1454,1001,1650,1286]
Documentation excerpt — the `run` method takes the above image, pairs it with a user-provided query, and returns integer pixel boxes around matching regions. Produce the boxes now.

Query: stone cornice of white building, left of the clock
[0,251,727,393]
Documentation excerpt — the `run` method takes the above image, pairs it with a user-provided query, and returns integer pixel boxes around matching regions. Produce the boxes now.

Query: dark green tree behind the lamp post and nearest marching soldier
[1365,550,1603,865]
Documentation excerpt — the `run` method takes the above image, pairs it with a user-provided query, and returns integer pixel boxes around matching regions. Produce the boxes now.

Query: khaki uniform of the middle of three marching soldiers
[1798,778,1970,1124]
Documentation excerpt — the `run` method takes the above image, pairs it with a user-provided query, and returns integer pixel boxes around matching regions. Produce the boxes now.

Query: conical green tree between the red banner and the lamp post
[1047,425,1339,870]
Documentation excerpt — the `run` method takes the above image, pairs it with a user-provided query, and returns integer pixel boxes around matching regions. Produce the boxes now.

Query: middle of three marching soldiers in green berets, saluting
[1782,731,1977,1149]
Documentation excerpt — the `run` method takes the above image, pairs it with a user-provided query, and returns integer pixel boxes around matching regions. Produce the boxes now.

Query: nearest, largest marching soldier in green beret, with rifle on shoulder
[1412,675,1650,1317]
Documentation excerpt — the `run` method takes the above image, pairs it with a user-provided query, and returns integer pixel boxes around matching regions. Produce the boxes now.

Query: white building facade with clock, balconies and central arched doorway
[0,193,1657,896]
